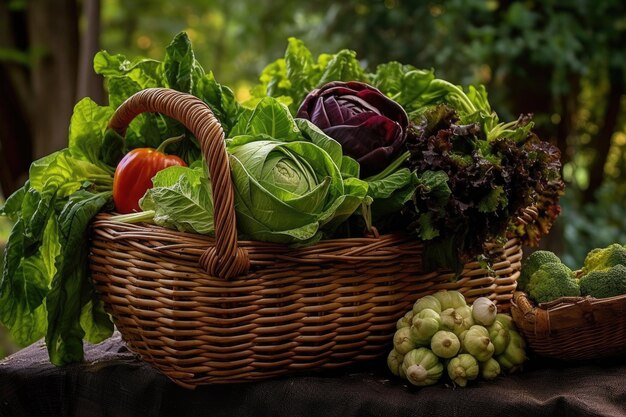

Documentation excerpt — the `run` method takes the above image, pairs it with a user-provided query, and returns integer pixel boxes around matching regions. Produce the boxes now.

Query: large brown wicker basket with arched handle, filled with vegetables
[90,89,532,387]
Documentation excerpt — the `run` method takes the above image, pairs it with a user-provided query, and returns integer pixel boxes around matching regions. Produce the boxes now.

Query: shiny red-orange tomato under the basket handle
[113,148,187,214]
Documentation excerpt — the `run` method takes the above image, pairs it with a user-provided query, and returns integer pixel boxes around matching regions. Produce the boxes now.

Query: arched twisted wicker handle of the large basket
[109,88,250,279]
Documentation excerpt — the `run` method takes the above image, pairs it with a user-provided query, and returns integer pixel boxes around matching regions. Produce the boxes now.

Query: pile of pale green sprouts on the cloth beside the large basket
[387,291,526,387]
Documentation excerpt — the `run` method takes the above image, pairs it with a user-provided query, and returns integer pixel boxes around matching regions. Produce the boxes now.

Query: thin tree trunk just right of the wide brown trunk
[76,0,104,105]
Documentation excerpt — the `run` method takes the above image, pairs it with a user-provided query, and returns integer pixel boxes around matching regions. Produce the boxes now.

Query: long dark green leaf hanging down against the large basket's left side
[46,190,111,365]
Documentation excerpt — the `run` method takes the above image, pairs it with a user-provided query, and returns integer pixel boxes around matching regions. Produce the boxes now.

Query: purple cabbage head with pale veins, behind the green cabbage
[297,81,408,178]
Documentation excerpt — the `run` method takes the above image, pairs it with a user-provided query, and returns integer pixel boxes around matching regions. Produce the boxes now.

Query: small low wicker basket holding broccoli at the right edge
[511,291,626,361]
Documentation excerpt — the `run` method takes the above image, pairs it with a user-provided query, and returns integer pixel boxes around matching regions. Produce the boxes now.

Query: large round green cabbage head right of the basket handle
[227,125,367,244]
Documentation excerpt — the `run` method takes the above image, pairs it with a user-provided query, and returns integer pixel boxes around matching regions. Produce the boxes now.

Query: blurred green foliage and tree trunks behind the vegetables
[0,0,626,290]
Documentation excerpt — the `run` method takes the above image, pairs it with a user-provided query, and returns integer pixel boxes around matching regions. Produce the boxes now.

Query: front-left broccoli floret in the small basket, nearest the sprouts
[527,262,580,303]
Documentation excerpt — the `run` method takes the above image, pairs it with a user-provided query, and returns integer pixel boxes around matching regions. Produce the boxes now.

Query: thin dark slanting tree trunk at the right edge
[582,67,625,203]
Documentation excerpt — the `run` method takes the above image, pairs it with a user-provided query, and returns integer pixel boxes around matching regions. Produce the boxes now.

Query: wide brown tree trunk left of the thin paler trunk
[27,0,78,159]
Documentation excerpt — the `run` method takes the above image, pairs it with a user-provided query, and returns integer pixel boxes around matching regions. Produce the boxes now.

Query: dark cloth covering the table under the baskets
[0,333,626,417]
